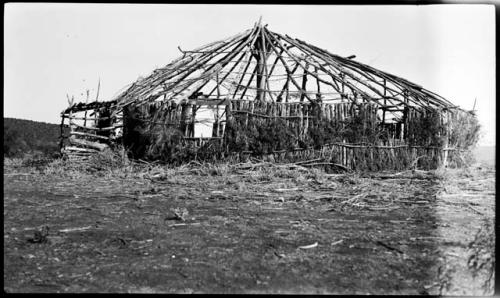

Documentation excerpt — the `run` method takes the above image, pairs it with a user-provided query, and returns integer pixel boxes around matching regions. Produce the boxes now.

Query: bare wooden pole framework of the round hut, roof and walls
[63,21,475,167]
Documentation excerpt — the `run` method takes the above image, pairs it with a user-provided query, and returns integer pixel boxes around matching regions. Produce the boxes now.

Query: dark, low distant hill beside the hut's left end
[3,118,67,157]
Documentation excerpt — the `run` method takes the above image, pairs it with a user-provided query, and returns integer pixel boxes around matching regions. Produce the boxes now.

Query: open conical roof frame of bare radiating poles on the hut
[116,20,456,114]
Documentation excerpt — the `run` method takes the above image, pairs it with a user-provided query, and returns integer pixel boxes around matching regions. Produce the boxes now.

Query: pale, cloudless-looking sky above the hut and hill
[4,3,495,145]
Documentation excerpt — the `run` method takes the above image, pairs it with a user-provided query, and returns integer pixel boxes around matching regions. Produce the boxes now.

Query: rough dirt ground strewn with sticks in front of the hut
[4,159,495,295]
